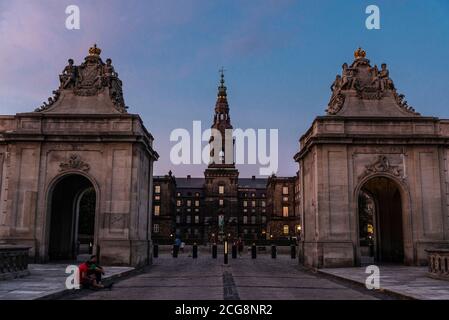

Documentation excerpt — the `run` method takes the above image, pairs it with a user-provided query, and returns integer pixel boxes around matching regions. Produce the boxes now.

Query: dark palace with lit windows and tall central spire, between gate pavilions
[153,73,301,243]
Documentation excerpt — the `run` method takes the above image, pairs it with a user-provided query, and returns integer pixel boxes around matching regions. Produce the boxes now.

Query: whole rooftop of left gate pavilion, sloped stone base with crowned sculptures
[34,45,127,114]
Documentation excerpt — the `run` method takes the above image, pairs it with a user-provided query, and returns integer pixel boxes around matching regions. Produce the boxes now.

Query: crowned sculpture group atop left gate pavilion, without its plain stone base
[35,45,127,113]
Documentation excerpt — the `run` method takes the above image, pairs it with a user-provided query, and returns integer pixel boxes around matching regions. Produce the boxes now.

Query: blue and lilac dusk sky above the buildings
[0,0,449,177]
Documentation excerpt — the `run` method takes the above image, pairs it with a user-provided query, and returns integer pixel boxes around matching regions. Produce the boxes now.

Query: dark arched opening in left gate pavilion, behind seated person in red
[48,174,96,260]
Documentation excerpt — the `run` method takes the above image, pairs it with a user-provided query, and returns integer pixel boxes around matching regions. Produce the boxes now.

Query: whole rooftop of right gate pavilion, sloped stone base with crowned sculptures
[326,48,420,117]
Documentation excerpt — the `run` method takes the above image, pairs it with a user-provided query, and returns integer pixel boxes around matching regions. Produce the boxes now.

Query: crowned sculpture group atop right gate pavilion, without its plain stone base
[326,48,419,115]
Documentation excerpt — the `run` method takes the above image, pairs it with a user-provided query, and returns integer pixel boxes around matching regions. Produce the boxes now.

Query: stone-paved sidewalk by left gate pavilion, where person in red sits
[0,264,134,300]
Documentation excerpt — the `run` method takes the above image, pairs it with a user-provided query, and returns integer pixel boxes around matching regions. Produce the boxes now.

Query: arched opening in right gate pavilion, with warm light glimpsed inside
[358,177,404,264]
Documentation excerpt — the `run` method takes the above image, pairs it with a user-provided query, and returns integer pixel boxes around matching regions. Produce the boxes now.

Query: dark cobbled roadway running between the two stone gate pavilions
[63,254,384,300]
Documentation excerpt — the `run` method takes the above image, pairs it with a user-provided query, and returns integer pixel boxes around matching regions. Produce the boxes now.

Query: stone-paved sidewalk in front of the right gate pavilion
[319,266,449,300]
